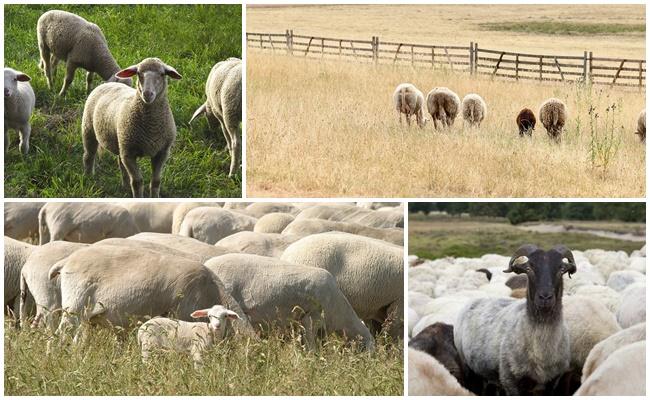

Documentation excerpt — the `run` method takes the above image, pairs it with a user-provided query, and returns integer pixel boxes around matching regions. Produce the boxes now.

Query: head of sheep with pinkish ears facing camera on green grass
[115,58,182,104]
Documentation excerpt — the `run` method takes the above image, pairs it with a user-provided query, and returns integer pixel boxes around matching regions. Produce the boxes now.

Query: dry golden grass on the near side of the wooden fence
[247,51,645,198]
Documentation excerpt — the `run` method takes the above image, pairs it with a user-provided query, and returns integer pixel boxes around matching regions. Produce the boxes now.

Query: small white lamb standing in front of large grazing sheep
[138,305,239,369]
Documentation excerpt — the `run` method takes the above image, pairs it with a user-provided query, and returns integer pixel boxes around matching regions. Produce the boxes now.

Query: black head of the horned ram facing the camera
[504,245,576,318]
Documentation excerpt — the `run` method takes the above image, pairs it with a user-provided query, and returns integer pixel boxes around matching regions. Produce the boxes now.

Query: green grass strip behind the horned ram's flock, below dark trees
[409,214,644,260]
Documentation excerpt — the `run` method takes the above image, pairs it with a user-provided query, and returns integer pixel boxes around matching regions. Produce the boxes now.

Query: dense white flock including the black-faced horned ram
[408,245,646,395]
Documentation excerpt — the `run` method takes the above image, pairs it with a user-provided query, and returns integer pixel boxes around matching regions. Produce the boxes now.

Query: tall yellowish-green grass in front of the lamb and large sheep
[4,322,404,396]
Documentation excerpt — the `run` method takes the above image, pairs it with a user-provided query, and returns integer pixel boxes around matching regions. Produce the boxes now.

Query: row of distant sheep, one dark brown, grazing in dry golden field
[393,83,645,142]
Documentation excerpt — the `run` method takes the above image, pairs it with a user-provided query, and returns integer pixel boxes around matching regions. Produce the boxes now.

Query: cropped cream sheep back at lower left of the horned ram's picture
[408,347,472,396]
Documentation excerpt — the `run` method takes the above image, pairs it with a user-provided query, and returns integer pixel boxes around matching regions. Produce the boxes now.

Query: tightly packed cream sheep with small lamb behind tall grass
[4,202,404,368]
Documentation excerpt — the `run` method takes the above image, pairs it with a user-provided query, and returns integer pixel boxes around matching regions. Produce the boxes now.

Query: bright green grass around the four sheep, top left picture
[4,5,241,197]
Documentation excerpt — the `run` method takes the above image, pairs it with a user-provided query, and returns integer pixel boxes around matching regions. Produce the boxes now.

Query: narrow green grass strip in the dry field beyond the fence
[479,21,645,35]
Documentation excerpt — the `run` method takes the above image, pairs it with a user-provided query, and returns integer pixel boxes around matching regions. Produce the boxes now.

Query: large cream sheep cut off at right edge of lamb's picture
[281,232,404,337]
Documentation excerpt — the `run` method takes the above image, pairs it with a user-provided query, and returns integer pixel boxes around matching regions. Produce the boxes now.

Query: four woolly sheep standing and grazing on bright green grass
[4,10,242,197]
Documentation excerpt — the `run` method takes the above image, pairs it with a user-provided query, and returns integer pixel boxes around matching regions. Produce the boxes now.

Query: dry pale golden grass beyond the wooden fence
[246,4,645,58]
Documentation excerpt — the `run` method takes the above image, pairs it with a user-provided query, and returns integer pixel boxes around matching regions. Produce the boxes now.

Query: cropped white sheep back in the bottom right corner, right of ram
[575,340,646,396]
